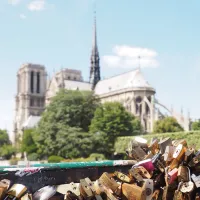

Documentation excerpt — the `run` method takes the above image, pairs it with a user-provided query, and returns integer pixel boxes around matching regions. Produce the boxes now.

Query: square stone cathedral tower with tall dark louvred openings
[14,64,46,142]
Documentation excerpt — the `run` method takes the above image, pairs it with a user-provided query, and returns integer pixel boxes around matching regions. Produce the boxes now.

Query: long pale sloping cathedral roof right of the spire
[95,69,154,95]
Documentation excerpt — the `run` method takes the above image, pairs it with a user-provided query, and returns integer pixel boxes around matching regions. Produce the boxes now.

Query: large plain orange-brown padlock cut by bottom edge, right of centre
[122,183,146,200]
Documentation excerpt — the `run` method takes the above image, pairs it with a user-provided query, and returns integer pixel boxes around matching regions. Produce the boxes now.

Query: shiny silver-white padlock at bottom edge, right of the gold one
[33,186,56,200]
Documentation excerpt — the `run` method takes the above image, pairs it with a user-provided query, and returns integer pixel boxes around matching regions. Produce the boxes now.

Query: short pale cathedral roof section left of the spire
[64,80,91,90]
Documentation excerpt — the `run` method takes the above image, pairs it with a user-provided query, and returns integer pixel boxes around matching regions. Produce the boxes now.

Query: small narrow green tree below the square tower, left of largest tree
[21,129,37,155]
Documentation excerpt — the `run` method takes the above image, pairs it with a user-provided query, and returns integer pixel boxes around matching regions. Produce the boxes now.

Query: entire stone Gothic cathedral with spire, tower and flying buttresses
[13,15,190,142]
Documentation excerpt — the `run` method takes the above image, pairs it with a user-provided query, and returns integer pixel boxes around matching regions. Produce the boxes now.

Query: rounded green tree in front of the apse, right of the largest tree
[90,102,141,157]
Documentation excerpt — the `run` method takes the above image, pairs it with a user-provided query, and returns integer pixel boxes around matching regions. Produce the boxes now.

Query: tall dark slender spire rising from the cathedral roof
[90,13,101,89]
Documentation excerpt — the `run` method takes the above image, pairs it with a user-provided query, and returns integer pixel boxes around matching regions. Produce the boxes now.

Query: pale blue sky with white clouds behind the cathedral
[0,0,200,139]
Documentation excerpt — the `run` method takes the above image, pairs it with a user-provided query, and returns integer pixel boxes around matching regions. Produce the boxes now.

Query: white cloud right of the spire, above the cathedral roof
[102,45,159,68]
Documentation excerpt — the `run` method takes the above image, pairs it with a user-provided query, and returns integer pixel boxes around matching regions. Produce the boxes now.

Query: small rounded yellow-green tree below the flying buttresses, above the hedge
[153,117,183,133]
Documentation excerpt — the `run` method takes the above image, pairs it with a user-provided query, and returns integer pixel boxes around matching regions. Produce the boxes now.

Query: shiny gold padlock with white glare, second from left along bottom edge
[5,184,27,199]
